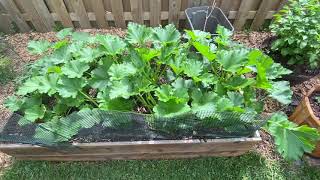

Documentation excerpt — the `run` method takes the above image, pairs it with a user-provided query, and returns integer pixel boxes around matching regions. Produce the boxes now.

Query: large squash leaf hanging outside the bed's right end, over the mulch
[267,113,320,160]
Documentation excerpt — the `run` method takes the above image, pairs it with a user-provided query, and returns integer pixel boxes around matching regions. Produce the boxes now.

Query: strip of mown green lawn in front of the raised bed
[2,153,320,180]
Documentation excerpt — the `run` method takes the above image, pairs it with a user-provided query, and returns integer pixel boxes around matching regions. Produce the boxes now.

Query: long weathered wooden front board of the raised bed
[0,131,261,161]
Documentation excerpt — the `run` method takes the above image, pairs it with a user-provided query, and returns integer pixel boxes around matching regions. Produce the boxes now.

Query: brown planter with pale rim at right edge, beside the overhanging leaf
[289,84,320,157]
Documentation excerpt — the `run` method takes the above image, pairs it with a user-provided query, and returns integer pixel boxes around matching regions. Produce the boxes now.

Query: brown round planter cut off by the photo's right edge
[289,85,320,158]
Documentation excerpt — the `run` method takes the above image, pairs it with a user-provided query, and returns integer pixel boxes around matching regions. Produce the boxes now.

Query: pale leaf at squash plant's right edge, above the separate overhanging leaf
[268,81,293,104]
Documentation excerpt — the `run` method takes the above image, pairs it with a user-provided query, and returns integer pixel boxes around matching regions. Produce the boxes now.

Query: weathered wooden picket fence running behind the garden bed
[0,0,286,32]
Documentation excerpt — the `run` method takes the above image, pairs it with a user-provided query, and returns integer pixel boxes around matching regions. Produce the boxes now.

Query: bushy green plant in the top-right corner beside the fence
[270,0,320,68]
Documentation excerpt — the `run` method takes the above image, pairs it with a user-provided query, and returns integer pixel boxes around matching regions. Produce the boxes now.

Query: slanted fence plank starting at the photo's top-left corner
[0,0,31,32]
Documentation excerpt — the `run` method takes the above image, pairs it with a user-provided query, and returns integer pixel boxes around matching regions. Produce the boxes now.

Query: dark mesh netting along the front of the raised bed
[0,110,269,147]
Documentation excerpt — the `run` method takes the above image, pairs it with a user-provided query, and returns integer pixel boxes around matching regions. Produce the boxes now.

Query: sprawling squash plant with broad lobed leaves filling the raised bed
[6,23,319,159]
